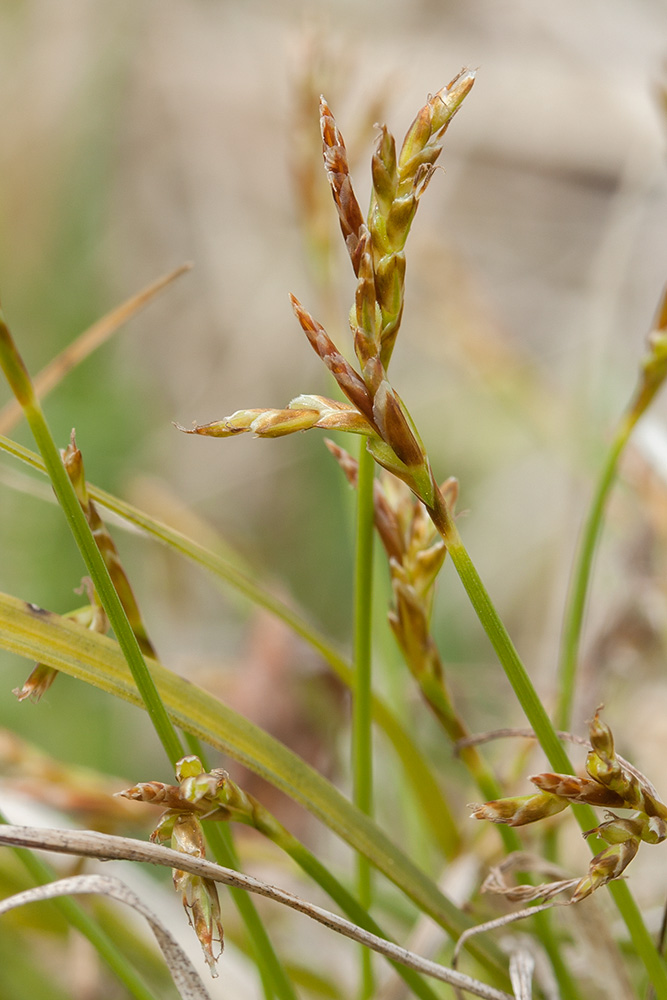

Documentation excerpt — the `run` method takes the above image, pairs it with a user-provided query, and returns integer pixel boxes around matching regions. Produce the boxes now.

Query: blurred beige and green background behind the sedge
[0,0,667,996]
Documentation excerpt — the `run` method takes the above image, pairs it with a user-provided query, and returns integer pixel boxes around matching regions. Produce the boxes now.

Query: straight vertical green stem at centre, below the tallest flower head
[352,439,375,1000]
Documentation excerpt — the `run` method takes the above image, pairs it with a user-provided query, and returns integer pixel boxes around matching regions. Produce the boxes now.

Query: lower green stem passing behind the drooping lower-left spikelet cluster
[185,733,297,1000]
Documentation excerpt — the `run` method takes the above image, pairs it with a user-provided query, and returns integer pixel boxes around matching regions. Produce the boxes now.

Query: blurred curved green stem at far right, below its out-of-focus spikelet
[555,411,637,729]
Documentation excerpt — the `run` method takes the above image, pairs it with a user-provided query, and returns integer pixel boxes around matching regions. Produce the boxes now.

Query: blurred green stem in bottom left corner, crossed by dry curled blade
[0,814,158,1000]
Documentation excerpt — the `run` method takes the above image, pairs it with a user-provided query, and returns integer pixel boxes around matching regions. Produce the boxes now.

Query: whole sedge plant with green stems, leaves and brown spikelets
[0,71,667,1000]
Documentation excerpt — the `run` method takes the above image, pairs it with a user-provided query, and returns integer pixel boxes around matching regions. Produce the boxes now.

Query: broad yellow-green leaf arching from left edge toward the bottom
[0,594,504,970]
